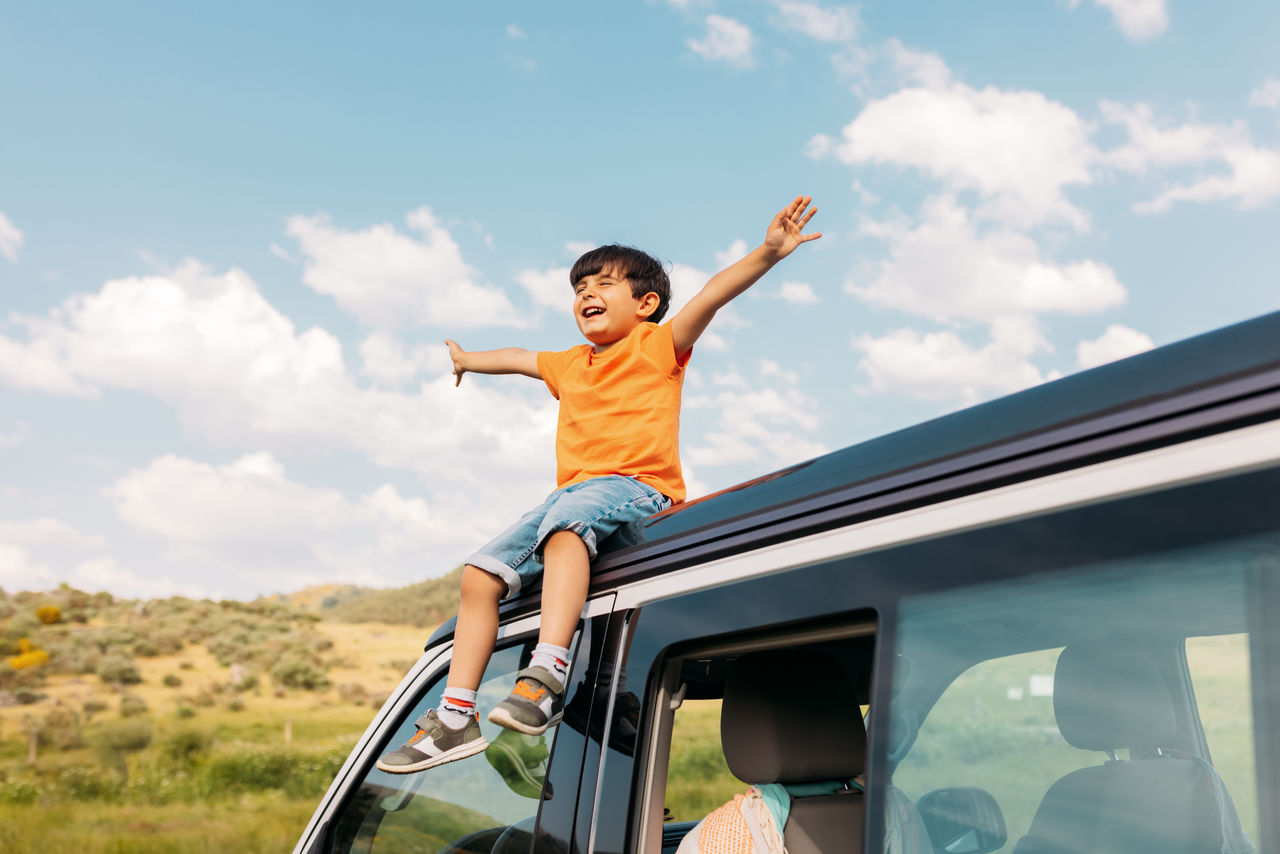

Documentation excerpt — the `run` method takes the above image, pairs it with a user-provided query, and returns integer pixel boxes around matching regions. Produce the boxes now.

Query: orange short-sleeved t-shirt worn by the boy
[538,321,691,504]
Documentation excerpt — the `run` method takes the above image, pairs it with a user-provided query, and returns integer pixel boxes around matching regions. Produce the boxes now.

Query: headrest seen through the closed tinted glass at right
[1053,639,1178,750]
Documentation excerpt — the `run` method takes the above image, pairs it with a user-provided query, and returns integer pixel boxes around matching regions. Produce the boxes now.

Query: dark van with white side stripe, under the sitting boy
[294,314,1280,854]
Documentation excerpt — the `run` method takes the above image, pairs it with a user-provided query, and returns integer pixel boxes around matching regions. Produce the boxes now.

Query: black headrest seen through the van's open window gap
[721,649,867,784]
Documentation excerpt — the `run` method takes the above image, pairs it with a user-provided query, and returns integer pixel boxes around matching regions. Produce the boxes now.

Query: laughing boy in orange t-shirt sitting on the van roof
[378,196,822,773]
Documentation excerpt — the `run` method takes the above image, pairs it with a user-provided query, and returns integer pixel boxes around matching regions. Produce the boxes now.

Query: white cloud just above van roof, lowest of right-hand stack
[852,318,1057,405]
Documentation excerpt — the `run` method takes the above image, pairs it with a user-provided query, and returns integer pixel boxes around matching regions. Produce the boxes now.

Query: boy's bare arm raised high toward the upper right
[671,196,822,357]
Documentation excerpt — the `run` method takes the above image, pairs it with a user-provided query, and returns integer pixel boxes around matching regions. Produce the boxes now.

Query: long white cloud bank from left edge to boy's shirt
[0,261,556,501]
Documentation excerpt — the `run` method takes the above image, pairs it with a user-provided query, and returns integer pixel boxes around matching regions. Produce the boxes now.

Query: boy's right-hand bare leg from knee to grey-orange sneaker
[489,530,591,735]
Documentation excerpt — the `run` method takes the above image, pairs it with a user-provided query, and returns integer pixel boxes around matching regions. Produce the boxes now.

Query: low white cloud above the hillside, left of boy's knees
[106,453,489,590]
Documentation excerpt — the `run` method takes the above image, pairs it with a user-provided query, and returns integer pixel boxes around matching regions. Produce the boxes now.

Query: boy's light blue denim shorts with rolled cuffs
[467,475,671,598]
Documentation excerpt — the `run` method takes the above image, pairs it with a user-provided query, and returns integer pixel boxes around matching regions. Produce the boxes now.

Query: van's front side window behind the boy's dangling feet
[328,641,556,854]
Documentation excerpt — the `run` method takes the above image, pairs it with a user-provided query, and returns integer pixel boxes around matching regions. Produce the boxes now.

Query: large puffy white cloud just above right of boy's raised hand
[808,71,1097,230]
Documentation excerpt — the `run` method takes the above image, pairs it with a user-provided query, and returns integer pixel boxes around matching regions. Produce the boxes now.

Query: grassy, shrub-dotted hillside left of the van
[0,579,445,854]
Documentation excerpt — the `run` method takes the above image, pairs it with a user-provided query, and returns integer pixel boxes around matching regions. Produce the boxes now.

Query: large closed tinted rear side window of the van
[890,542,1277,854]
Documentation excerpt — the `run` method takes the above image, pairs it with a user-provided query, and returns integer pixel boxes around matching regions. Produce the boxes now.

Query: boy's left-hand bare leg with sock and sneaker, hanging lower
[378,565,507,773]
